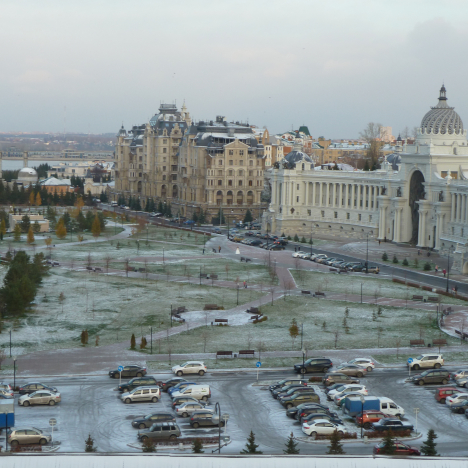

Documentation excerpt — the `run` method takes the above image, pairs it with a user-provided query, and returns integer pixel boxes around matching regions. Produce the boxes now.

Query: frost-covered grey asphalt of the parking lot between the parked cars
[0,369,468,456]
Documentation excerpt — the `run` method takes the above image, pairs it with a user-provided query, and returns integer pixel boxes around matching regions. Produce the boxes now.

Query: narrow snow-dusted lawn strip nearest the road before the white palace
[291,270,467,305]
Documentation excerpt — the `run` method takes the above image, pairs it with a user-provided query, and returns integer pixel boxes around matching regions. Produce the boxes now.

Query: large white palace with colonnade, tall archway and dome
[263,86,468,273]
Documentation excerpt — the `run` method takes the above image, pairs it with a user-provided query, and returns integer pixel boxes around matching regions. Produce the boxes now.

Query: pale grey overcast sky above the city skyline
[0,0,468,138]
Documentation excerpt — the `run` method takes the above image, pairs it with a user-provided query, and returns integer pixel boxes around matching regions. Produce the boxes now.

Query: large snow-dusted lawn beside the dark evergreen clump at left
[0,268,260,354]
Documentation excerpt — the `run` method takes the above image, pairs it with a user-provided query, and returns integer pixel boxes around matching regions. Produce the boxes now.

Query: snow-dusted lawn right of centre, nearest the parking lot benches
[140,296,459,353]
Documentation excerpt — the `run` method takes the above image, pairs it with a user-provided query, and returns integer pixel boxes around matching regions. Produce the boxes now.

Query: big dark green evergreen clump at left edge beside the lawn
[0,250,48,315]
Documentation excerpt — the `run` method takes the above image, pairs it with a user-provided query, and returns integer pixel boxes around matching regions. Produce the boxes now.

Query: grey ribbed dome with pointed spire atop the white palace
[421,85,463,135]
